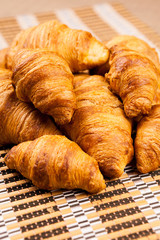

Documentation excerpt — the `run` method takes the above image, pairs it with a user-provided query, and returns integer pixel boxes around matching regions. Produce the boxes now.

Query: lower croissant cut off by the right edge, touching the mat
[135,104,160,173]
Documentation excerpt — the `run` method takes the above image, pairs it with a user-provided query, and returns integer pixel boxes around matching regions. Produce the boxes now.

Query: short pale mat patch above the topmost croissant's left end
[16,14,39,29]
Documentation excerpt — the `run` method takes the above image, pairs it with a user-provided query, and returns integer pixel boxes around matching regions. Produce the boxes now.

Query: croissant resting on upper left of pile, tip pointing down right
[13,49,76,124]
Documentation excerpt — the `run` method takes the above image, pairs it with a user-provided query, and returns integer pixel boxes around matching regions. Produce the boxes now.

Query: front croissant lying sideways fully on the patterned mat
[5,135,105,193]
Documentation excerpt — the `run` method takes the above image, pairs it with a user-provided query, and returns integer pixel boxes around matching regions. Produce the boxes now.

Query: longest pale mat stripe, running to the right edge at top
[93,3,160,56]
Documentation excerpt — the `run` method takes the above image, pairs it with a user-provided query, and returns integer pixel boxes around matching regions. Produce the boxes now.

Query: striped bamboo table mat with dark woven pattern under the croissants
[0,2,160,240]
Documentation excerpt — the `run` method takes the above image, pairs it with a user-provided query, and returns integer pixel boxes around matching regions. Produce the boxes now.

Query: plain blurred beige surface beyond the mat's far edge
[0,0,160,34]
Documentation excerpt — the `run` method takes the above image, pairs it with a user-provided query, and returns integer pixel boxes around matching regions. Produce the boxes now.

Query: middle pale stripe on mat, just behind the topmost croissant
[55,8,98,38]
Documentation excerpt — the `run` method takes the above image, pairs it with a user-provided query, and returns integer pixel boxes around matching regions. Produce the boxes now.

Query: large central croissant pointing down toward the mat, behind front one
[62,74,133,178]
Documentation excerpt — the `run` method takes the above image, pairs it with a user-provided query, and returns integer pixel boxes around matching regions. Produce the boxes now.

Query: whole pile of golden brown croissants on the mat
[0,20,160,193]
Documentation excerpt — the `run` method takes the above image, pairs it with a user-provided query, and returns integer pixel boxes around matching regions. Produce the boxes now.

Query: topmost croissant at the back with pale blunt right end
[7,20,109,72]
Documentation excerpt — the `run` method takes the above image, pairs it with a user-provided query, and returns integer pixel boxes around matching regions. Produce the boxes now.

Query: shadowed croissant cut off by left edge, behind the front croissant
[0,68,60,145]
